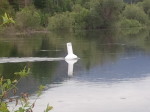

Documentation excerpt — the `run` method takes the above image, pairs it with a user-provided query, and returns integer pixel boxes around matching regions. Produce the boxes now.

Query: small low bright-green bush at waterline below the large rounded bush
[119,18,142,28]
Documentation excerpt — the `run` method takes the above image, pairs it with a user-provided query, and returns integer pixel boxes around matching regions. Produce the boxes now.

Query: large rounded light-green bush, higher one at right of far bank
[123,5,148,24]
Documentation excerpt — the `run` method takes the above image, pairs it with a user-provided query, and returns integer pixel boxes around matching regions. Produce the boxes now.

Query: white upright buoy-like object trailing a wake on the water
[65,42,79,60]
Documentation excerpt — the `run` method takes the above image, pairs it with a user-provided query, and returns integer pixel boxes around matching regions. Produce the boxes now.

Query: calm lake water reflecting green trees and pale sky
[0,30,150,112]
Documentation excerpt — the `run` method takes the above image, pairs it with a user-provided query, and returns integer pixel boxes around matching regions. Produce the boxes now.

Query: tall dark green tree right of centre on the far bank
[88,0,124,29]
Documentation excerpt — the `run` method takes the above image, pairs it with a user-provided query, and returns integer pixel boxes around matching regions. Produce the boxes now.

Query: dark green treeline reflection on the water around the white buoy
[0,29,150,93]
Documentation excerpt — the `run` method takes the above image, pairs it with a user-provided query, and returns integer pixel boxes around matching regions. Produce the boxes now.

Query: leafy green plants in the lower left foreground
[0,68,53,112]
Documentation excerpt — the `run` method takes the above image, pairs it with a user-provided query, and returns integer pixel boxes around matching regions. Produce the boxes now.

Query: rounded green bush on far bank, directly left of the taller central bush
[48,12,73,31]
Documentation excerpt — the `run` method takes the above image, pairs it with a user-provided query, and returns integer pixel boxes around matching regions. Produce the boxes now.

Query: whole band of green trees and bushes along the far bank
[0,0,150,31]
